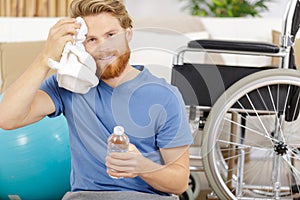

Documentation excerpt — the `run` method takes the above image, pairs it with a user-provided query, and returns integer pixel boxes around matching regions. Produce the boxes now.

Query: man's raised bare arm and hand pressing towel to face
[0,18,80,129]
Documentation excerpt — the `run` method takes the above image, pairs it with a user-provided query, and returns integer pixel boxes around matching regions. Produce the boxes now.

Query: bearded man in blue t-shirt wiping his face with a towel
[0,0,192,199]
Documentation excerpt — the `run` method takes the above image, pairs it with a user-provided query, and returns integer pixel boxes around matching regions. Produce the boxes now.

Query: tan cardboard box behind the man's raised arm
[0,41,53,93]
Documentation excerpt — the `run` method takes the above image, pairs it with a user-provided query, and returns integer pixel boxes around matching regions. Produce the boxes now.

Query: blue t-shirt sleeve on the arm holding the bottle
[157,88,193,148]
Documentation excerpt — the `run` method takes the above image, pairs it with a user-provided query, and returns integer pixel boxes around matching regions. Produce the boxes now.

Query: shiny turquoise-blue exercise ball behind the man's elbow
[0,97,71,200]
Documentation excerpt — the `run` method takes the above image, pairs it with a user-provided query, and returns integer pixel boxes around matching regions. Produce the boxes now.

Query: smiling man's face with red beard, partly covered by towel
[84,13,131,80]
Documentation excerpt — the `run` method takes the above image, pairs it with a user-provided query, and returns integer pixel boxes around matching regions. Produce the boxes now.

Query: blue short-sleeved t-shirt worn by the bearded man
[41,68,193,195]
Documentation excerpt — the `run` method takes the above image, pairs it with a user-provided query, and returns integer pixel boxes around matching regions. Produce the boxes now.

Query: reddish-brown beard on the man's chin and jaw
[100,52,130,80]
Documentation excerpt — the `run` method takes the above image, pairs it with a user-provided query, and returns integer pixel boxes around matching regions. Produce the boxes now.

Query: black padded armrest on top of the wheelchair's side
[188,40,280,53]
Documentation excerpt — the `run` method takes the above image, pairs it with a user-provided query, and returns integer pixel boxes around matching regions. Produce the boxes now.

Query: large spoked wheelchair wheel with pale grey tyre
[202,69,300,199]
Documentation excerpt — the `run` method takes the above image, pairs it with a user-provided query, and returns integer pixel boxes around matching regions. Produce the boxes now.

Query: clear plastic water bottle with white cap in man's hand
[107,126,129,178]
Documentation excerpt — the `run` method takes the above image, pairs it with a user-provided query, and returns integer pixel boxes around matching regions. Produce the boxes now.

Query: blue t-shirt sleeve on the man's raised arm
[40,75,63,117]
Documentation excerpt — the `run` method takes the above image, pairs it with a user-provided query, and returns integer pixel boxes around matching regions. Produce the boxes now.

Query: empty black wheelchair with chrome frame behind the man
[171,0,300,200]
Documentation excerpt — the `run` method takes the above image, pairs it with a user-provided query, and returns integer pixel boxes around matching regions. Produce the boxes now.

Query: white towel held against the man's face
[48,17,99,94]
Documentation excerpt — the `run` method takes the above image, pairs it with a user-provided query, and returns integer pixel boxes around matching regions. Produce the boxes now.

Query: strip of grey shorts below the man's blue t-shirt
[62,191,179,200]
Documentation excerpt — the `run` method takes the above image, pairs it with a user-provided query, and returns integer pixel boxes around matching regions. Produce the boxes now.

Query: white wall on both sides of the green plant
[125,0,289,18]
